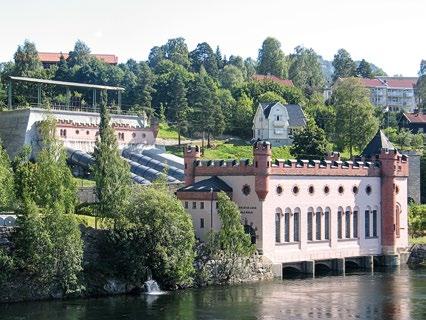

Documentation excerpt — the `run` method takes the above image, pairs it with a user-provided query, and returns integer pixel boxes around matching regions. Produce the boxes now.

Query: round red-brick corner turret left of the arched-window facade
[253,141,272,201]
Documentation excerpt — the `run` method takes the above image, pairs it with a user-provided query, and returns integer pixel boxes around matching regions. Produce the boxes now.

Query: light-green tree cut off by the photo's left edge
[0,140,15,210]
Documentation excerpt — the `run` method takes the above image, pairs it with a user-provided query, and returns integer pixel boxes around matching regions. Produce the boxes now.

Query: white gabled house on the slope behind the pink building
[253,102,306,146]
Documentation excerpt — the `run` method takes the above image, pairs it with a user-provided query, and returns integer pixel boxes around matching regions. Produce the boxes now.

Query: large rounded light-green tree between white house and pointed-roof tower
[331,78,379,158]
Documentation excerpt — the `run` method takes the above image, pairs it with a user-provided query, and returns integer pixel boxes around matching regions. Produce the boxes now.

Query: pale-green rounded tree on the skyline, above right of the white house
[288,47,325,97]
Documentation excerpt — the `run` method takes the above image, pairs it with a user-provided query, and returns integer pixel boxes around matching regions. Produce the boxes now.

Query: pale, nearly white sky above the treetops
[0,0,426,76]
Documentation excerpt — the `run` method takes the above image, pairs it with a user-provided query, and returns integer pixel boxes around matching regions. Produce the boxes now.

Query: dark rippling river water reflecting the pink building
[0,268,426,320]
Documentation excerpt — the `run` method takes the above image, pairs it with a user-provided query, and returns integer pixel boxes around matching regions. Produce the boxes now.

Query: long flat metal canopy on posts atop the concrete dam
[8,76,124,109]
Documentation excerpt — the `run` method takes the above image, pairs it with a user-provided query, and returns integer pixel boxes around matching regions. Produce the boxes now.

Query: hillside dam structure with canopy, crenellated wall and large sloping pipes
[0,77,184,184]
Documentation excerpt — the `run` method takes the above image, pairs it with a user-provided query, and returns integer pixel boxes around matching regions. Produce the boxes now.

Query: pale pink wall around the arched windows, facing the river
[263,176,381,263]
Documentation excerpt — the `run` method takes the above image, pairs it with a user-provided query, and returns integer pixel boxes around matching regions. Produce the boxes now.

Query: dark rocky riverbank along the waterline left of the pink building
[0,225,273,303]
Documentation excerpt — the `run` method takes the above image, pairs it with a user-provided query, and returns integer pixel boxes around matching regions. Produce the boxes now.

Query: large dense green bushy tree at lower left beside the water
[12,203,83,295]
